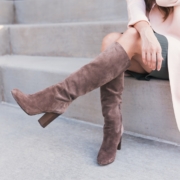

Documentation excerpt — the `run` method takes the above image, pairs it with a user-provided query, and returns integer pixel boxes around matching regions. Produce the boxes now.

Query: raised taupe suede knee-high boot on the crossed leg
[11,42,130,127]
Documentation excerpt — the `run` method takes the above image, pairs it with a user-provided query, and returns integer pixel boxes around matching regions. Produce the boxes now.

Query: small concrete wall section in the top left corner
[0,0,15,24]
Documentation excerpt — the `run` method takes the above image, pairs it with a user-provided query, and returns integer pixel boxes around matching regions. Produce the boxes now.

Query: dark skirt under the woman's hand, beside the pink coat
[125,32,169,81]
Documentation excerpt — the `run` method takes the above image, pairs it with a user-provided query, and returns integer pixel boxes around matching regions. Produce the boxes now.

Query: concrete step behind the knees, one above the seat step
[0,21,127,57]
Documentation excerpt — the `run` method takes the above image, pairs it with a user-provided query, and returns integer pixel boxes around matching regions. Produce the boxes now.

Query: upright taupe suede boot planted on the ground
[97,73,124,165]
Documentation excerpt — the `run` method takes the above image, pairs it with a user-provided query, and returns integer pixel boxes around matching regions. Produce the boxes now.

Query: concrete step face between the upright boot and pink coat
[122,77,180,143]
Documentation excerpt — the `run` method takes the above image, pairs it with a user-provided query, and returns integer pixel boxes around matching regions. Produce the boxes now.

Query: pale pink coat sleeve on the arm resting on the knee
[126,0,151,28]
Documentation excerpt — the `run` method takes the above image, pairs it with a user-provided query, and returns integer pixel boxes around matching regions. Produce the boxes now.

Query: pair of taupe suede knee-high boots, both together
[11,42,130,165]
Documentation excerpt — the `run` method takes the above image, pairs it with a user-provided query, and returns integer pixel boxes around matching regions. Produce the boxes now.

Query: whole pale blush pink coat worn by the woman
[127,0,180,131]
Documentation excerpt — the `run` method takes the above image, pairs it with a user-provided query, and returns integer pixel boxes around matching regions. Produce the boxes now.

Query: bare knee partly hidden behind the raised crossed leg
[102,32,121,51]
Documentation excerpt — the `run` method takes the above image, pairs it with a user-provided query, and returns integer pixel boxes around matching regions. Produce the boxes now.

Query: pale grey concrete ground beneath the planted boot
[0,102,180,180]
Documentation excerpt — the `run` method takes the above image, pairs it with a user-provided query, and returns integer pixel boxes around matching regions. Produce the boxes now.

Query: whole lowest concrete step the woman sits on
[0,55,180,144]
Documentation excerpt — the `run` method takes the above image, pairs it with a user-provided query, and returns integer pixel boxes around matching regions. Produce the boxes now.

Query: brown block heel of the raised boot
[38,113,60,128]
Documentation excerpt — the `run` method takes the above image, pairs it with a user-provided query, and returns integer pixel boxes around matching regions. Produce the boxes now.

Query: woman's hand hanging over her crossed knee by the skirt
[140,27,163,71]
